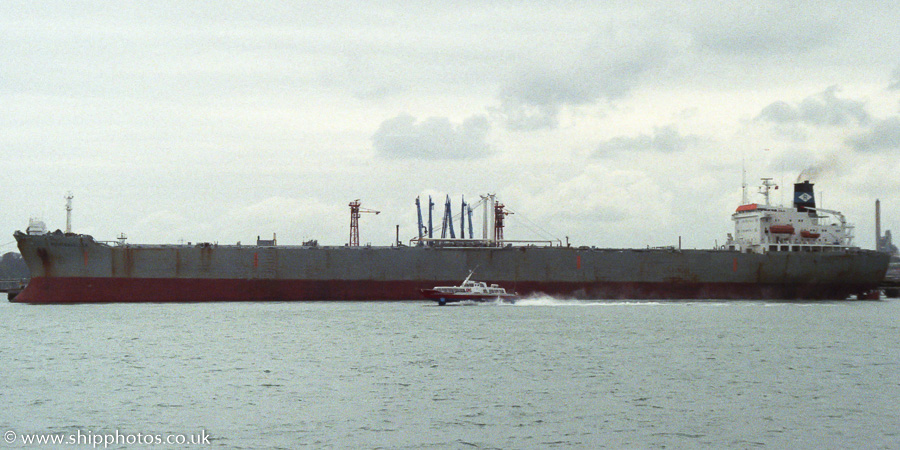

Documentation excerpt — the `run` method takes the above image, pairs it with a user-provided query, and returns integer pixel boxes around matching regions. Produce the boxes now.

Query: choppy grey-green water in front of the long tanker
[0,299,900,448]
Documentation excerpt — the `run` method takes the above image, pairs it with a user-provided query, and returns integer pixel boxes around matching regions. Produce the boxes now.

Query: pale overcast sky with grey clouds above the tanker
[0,1,900,252]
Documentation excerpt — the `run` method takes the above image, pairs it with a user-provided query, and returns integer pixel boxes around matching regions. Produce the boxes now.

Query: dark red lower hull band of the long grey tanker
[11,277,873,303]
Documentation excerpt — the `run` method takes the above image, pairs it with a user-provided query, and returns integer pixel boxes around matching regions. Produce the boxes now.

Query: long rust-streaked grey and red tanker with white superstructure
[14,179,889,303]
